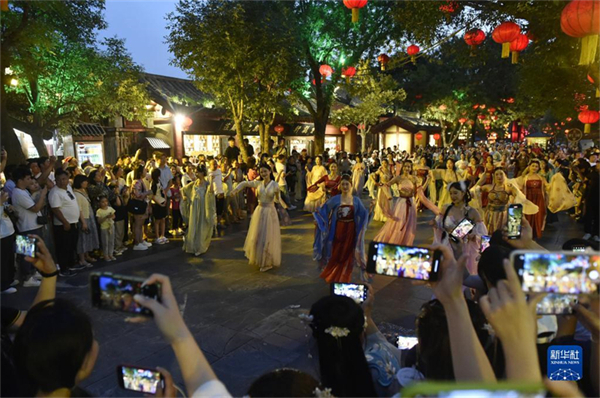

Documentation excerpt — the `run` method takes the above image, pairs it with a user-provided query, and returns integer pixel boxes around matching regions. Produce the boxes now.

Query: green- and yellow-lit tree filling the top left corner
[1,0,149,163]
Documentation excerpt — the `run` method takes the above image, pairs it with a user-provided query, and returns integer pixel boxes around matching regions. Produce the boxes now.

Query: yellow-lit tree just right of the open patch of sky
[167,0,299,159]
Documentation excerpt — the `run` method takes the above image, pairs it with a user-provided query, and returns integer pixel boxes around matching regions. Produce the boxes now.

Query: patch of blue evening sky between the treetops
[99,0,186,78]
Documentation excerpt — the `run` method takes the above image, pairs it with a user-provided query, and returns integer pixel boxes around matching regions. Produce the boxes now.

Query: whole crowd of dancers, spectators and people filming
[1,138,600,397]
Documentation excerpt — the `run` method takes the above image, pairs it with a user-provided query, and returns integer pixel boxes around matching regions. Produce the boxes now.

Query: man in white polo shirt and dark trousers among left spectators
[48,169,85,277]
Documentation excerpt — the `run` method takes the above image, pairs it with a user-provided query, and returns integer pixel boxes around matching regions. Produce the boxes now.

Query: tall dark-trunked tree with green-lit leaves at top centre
[292,0,396,153]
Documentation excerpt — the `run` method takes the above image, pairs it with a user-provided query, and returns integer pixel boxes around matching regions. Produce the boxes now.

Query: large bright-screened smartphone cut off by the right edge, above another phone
[511,250,600,294]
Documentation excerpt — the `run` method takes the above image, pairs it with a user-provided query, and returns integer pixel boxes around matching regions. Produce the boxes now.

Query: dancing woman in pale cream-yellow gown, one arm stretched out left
[230,164,287,272]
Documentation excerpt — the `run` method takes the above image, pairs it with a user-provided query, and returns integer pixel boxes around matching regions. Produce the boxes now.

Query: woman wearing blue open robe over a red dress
[313,175,369,283]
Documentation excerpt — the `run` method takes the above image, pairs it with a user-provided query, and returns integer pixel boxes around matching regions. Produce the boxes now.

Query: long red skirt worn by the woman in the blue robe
[320,205,356,283]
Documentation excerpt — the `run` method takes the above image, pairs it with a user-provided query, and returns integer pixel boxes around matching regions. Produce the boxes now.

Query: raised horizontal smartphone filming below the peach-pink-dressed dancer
[367,242,441,281]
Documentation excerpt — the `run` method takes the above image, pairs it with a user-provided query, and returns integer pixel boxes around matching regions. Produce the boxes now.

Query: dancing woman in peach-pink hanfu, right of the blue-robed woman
[373,160,418,246]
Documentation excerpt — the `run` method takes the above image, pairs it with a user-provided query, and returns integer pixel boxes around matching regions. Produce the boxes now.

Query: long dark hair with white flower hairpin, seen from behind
[310,296,377,397]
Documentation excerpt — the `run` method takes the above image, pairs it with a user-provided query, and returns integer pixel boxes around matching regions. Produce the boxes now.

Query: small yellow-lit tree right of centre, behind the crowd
[331,63,406,153]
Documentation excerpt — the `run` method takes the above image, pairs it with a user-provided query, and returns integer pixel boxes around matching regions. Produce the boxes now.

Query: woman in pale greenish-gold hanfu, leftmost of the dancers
[180,166,217,256]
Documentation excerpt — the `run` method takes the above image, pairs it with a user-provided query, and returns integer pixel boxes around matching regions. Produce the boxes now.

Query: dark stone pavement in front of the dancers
[2,207,582,397]
